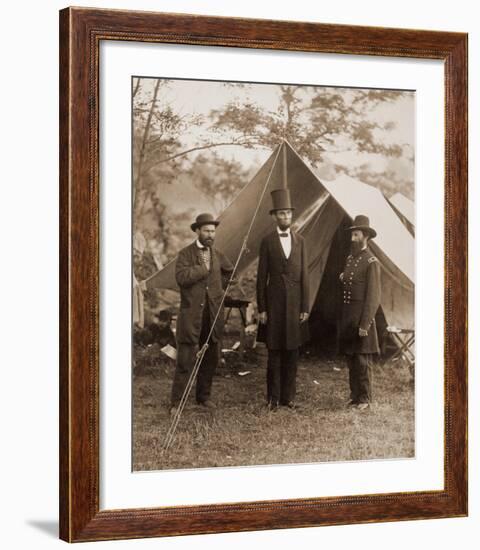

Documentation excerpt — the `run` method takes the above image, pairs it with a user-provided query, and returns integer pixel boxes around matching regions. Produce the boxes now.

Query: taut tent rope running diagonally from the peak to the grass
[163,145,285,451]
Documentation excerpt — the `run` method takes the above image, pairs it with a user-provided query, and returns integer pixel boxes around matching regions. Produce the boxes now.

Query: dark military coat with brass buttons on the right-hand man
[339,247,380,355]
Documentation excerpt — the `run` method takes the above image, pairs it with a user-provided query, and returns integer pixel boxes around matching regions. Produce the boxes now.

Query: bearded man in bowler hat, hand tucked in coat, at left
[170,214,233,414]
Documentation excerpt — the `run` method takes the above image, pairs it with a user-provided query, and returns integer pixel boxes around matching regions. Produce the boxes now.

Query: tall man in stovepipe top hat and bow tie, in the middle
[257,189,309,409]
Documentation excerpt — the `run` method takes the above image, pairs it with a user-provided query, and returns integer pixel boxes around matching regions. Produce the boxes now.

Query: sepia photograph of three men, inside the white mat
[131,76,416,471]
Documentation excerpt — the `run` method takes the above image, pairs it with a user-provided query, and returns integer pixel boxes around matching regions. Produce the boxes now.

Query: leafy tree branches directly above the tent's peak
[211,85,402,166]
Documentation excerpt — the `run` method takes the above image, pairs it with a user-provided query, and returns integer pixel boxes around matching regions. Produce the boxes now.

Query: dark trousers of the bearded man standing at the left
[171,307,219,406]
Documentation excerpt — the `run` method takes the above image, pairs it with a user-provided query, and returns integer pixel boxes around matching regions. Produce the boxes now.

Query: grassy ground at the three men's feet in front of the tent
[133,346,415,471]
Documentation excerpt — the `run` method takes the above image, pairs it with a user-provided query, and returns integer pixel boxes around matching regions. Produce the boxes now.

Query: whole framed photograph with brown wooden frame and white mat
[60,8,467,542]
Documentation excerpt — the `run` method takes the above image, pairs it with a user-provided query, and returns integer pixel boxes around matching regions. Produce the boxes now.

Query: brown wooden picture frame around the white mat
[59,8,467,542]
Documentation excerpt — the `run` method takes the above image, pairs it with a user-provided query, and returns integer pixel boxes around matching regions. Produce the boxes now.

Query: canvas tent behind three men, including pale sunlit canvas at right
[147,141,415,354]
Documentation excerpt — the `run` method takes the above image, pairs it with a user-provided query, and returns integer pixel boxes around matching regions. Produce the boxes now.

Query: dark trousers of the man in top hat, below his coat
[267,349,298,405]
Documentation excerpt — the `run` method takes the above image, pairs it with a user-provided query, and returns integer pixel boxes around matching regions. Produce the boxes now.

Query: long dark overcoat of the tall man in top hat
[257,231,310,349]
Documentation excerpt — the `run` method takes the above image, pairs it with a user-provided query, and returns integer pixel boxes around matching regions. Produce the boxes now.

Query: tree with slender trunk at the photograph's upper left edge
[132,78,256,274]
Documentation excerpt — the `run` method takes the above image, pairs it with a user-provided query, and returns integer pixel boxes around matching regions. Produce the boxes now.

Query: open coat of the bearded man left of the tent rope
[175,242,233,344]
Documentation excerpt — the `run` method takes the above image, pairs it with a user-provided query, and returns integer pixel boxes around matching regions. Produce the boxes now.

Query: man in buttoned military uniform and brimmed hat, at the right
[340,215,380,410]
